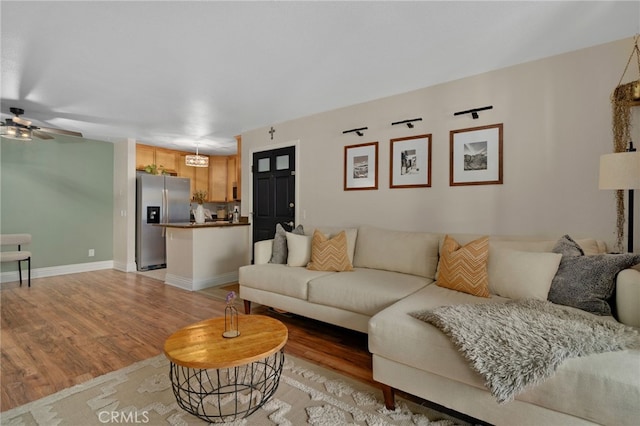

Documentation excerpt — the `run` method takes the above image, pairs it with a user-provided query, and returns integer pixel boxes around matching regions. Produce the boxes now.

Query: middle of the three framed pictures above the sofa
[389,133,431,188]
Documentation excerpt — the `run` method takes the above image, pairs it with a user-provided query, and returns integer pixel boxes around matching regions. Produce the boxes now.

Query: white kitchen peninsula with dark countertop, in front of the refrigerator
[157,222,251,291]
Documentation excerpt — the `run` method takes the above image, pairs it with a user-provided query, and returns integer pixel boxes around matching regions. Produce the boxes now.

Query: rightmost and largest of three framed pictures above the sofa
[449,123,503,186]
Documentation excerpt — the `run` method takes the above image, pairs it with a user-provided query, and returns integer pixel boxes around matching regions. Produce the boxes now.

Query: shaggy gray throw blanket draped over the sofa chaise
[410,299,640,403]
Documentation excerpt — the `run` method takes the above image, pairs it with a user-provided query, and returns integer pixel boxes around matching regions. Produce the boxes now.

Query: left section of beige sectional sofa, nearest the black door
[239,228,439,333]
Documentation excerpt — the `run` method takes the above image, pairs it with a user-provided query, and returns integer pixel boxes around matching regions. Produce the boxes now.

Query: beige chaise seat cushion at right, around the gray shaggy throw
[369,285,640,424]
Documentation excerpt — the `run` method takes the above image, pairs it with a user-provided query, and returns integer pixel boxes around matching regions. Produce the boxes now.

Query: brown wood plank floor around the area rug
[0,270,372,411]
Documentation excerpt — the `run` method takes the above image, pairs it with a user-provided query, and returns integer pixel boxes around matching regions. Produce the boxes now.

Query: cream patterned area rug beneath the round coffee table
[0,355,466,426]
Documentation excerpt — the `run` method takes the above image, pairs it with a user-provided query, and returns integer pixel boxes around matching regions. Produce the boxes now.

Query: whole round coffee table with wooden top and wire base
[164,315,288,423]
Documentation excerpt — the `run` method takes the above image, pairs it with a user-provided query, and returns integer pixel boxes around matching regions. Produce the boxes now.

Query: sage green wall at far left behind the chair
[0,136,114,271]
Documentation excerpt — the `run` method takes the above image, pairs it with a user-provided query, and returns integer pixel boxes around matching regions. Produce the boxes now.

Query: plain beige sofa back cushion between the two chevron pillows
[353,226,439,279]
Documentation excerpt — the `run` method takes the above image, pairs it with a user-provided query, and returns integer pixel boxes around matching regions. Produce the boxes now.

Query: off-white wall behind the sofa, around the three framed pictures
[242,39,640,248]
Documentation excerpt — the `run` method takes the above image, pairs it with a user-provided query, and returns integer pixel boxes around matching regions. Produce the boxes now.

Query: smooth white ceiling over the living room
[0,0,640,155]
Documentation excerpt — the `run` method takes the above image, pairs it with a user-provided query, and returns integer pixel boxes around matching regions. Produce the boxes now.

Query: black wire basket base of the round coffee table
[169,351,284,423]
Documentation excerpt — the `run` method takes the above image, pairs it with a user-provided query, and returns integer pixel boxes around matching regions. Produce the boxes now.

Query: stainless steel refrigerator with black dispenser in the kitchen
[136,173,191,271]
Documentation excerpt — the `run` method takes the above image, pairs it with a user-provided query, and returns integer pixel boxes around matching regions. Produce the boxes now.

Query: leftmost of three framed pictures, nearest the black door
[344,142,378,191]
